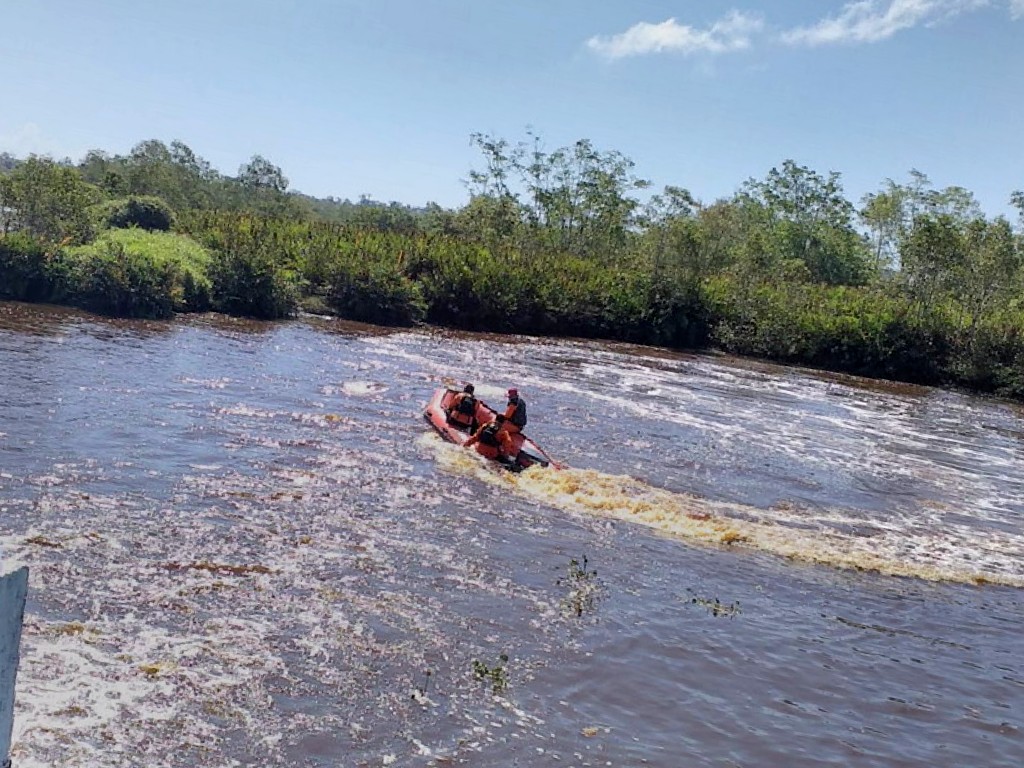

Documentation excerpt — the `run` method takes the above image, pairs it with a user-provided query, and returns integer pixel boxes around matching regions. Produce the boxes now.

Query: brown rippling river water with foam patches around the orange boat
[0,303,1024,768]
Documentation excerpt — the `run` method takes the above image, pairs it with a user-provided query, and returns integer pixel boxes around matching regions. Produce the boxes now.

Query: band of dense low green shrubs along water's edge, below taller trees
[0,227,1024,401]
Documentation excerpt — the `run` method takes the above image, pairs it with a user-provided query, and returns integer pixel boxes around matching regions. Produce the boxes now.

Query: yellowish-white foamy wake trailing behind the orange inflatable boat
[430,437,1024,588]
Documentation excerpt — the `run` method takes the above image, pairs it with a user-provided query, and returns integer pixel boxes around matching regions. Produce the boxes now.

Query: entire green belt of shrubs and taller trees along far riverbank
[0,135,1024,398]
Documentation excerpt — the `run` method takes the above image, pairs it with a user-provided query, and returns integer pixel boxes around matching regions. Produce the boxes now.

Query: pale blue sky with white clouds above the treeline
[0,0,1024,215]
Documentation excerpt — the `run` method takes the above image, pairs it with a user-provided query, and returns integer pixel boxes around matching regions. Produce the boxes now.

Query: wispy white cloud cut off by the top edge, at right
[781,0,991,46]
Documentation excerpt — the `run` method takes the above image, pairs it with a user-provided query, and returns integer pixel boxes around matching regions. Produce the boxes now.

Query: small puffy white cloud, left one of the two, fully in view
[587,11,765,58]
